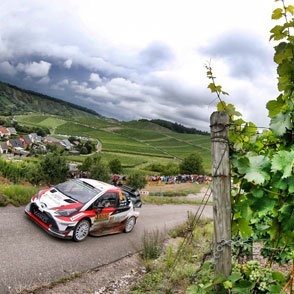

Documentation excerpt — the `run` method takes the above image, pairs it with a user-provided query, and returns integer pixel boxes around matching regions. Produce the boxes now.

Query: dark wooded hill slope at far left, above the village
[0,82,101,117]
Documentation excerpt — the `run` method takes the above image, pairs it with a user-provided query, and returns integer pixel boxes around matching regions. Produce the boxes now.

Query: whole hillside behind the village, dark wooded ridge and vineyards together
[0,82,211,172]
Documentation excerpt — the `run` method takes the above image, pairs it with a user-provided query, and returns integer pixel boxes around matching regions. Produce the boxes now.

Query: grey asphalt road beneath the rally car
[0,204,212,294]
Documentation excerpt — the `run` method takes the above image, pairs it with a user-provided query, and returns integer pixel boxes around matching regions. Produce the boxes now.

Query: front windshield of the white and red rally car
[55,180,101,203]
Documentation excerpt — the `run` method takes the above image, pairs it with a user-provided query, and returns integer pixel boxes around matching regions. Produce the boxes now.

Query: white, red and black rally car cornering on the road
[25,179,139,242]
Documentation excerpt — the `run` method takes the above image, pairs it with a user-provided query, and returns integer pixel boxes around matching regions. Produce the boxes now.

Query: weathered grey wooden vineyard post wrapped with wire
[210,111,232,277]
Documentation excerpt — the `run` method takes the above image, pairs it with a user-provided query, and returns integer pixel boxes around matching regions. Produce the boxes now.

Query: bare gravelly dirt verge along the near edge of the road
[20,254,145,294]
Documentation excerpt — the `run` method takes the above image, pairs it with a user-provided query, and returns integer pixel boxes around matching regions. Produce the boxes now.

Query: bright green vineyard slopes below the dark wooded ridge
[17,114,211,173]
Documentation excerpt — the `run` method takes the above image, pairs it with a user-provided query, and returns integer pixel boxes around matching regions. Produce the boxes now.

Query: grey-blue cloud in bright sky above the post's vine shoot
[198,31,274,79]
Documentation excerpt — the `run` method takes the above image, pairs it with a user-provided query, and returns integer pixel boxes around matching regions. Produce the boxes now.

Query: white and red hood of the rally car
[37,189,83,210]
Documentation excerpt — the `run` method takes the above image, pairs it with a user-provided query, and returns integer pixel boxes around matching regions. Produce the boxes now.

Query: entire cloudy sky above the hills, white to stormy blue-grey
[0,0,278,130]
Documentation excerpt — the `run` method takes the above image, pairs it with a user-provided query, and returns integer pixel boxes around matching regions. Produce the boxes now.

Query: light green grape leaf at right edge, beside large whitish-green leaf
[272,150,294,179]
